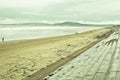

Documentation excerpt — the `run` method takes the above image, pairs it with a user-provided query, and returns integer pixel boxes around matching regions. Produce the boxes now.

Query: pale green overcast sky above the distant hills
[0,0,120,23]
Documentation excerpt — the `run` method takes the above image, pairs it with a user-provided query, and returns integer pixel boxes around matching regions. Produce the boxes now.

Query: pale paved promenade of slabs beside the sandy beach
[43,31,120,80]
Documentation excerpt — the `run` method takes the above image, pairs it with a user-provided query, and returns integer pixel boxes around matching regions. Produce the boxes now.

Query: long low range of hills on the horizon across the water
[0,22,111,26]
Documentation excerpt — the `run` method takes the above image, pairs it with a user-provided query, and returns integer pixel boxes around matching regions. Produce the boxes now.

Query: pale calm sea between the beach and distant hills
[0,26,103,41]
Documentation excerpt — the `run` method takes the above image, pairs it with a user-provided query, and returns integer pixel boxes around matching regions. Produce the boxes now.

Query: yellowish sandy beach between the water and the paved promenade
[0,28,114,80]
